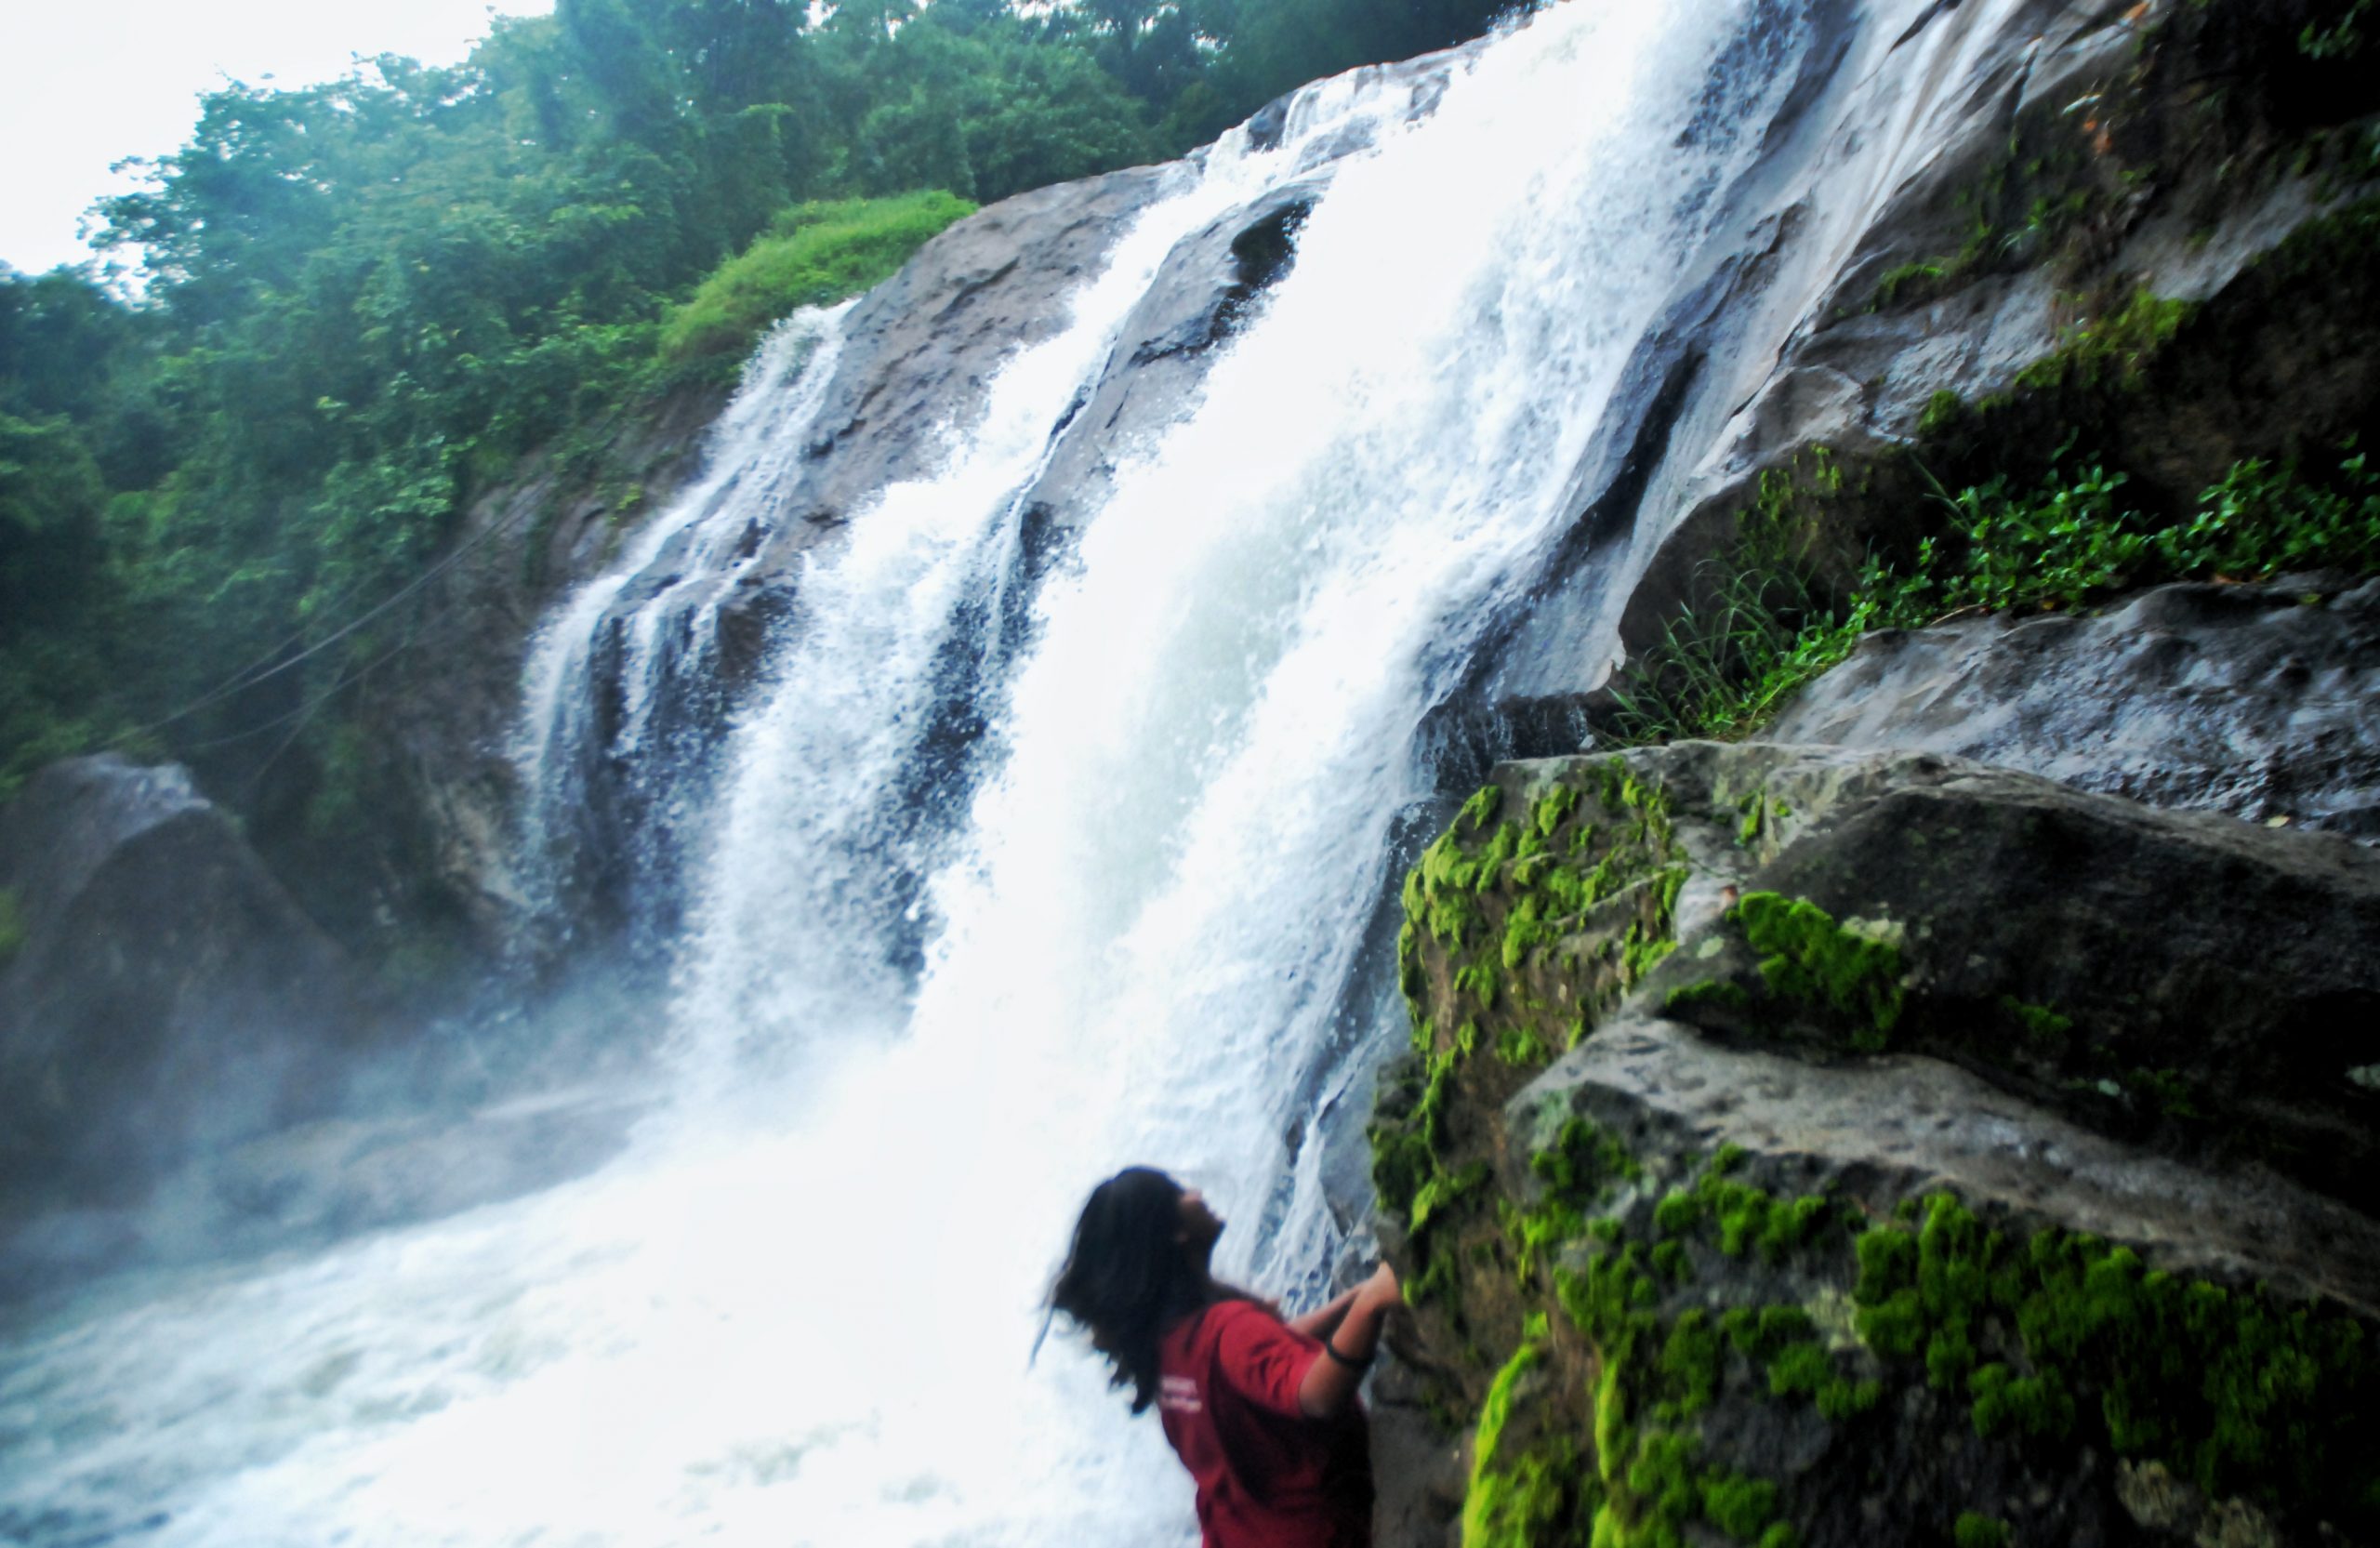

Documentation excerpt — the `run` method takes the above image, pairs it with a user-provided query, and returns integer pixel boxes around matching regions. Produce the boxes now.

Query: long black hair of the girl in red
[1045,1167,1250,1415]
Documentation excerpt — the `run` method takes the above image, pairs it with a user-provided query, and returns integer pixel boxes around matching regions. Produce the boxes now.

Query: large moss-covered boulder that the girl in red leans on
[1373,743,2380,1545]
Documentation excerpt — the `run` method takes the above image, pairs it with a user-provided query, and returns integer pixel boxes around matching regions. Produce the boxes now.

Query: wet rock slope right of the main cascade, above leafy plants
[1471,0,2380,728]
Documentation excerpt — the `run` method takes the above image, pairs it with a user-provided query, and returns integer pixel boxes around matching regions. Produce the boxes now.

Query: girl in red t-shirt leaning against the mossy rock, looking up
[1050,1167,1399,1548]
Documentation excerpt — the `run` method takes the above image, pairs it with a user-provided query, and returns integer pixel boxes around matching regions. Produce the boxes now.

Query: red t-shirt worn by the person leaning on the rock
[1157,1301,1371,1548]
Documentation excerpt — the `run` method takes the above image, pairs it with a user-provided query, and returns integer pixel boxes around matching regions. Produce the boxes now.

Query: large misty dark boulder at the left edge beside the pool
[0,755,376,1203]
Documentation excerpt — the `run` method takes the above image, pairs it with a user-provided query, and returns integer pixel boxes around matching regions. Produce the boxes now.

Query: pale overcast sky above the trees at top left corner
[0,0,552,271]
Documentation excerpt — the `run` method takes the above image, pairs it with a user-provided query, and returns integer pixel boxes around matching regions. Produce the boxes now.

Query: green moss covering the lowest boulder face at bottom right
[1390,1095,2380,1548]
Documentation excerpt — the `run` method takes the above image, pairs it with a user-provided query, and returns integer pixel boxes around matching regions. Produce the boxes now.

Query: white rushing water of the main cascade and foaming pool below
[0,0,1828,1548]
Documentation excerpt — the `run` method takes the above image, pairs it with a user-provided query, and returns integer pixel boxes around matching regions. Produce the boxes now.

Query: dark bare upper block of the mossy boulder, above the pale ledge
[1642,743,2380,1214]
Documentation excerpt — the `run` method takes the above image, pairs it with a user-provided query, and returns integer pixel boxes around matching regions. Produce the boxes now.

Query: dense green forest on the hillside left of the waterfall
[0,0,1512,819]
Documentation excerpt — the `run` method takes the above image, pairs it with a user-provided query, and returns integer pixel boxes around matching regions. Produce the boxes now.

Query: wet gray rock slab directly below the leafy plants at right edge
[1768,578,2380,839]
